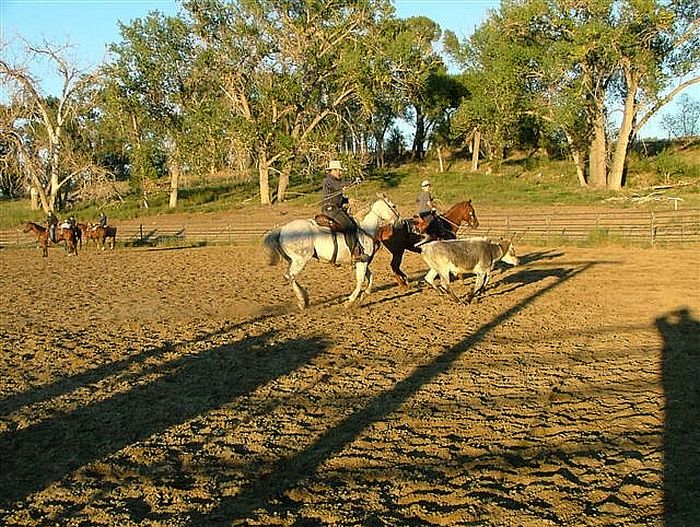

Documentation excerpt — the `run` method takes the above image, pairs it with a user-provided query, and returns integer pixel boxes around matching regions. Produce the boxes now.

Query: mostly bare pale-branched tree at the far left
[0,41,95,212]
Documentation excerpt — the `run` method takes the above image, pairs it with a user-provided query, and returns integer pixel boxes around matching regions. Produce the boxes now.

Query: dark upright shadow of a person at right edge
[656,308,700,527]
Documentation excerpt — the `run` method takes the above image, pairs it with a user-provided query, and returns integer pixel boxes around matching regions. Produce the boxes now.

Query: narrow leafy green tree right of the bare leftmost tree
[103,12,206,208]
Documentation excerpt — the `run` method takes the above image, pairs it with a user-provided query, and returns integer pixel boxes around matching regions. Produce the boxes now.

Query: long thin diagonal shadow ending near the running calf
[191,263,596,527]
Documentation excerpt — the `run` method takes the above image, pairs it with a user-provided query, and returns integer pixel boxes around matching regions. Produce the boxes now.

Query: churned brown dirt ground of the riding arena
[0,228,700,527]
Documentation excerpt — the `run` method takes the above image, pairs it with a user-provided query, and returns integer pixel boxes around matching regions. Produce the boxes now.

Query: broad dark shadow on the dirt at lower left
[0,332,327,509]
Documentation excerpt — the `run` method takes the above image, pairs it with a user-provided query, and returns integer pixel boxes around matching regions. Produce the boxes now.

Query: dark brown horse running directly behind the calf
[377,200,479,289]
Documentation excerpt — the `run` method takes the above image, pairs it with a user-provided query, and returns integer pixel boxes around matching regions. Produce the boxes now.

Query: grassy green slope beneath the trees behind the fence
[0,141,700,228]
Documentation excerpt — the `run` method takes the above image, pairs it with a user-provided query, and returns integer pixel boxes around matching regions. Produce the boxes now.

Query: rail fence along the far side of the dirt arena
[5,209,700,247]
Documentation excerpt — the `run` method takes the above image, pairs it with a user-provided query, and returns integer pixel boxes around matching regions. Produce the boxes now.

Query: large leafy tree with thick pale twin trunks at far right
[446,0,700,190]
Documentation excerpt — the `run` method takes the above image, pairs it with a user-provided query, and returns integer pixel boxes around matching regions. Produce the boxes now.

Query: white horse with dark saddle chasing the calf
[263,194,399,309]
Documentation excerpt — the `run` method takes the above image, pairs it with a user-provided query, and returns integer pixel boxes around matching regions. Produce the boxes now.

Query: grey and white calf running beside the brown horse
[421,237,518,302]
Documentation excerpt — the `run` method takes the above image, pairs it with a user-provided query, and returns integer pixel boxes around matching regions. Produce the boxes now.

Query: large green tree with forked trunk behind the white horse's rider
[184,0,391,204]
